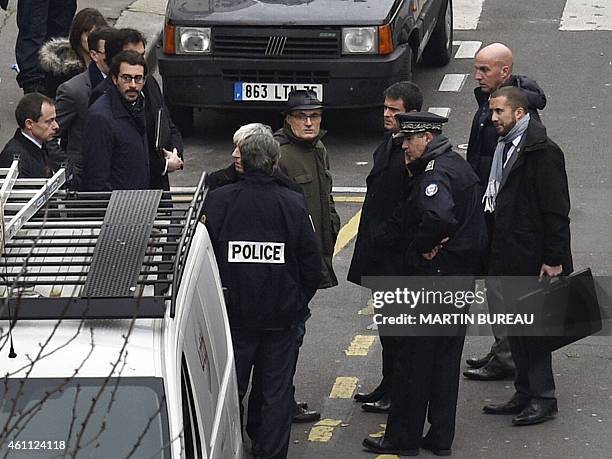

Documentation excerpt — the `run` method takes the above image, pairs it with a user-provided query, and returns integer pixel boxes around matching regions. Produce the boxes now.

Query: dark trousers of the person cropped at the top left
[15,0,76,87]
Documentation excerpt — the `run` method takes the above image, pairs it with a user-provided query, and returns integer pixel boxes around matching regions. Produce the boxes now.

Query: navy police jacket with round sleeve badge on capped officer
[402,134,487,275]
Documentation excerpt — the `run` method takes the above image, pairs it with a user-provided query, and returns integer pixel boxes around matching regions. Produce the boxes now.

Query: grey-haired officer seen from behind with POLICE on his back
[204,134,321,458]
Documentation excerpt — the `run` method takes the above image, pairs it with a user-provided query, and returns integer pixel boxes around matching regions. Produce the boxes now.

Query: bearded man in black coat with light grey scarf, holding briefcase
[484,88,573,425]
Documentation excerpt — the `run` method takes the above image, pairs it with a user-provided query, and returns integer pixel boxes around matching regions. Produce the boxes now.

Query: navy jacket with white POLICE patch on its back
[204,173,321,329]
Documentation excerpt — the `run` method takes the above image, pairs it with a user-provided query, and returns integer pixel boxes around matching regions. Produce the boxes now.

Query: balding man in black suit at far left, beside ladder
[0,92,59,178]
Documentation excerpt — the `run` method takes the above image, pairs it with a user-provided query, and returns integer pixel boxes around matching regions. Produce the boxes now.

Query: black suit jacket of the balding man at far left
[0,129,53,178]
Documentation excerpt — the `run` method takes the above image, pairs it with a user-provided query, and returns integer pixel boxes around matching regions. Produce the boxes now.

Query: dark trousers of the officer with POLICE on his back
[232,329,295,459]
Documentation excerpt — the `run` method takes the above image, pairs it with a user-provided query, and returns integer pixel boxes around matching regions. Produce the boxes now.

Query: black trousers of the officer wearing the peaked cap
[385,335,465,449]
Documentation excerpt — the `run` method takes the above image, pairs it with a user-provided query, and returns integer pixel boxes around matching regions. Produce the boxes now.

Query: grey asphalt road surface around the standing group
[0,0,612,459]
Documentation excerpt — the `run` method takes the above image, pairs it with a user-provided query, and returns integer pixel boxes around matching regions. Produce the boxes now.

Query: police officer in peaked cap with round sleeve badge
[363,112,487,456]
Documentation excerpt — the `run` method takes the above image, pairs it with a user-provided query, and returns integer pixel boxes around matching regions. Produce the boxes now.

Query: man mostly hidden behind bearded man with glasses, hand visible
[89,28,183,191]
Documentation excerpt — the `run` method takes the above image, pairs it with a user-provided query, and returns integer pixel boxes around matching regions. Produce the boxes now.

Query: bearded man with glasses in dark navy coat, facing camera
[81,51,163,191]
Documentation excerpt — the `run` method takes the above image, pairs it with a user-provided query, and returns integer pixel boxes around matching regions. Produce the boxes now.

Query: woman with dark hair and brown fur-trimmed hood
[39,8,107,98]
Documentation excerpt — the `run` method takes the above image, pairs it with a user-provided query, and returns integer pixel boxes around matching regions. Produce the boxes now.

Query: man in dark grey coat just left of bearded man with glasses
[55,27,116,189]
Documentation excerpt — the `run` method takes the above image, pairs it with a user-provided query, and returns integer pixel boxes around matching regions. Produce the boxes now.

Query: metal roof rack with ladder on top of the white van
[0,163,207,320]
